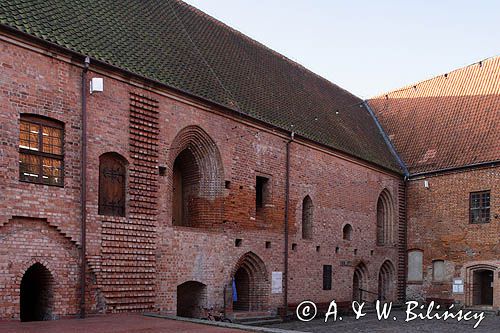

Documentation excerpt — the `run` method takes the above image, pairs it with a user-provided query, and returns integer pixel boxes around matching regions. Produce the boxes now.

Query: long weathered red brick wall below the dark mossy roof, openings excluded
[0,34,401,318]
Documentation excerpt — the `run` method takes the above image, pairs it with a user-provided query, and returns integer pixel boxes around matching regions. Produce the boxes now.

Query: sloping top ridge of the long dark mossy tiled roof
[177,0,363,101]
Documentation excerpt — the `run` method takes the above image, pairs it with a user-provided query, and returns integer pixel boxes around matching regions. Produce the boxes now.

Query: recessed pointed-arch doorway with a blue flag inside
[233,252,269,311]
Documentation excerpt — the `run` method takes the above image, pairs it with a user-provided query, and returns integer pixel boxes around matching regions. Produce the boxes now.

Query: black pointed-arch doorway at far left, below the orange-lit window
[20,263,53,321]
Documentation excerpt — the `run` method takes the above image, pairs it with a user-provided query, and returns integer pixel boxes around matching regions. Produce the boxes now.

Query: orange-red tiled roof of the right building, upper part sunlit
[369,57,500,174]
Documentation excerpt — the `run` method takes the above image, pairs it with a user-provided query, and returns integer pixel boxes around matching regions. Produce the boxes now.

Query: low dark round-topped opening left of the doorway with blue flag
[177,281,207,318]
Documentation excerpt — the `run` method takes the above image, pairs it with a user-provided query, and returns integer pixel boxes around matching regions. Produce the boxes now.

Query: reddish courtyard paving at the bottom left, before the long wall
[0,314,252,333]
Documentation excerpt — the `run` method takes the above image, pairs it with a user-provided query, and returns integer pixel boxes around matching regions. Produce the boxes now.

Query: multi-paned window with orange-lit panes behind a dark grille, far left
[19,115,64,186]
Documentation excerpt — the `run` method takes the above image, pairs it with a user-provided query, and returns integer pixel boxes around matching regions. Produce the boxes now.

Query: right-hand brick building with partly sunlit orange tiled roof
[369,57,500,310]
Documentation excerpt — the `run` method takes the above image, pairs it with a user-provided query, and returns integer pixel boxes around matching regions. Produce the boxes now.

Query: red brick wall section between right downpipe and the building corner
[289,144,399,303]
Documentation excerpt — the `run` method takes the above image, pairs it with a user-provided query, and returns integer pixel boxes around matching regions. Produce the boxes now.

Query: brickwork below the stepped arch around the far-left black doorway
[0,217,79,319]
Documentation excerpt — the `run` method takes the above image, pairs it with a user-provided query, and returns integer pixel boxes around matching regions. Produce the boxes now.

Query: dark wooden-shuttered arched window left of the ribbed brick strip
[99,153,126,216]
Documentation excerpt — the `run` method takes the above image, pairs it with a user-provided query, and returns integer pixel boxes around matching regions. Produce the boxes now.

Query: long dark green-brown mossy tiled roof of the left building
[0,0,400,172]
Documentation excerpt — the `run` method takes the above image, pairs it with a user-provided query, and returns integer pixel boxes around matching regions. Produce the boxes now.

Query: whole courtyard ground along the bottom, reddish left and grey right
[0,310,500,333]
